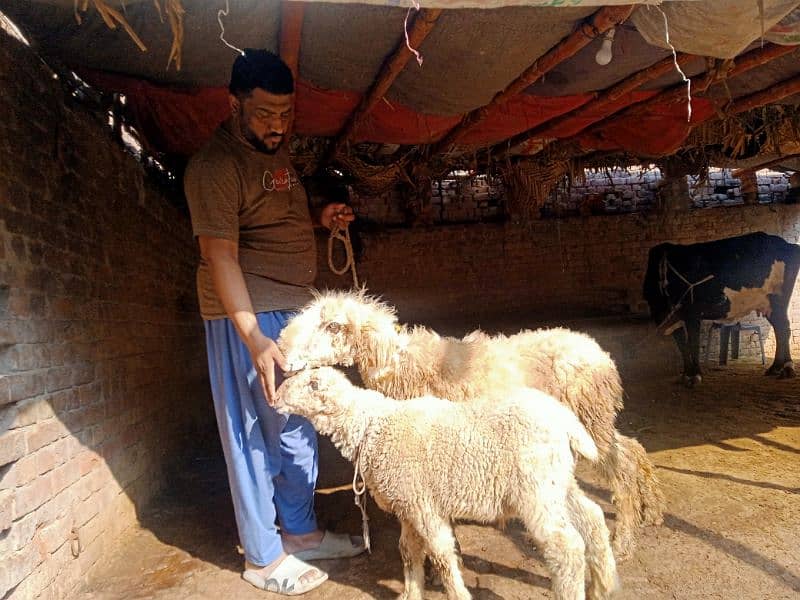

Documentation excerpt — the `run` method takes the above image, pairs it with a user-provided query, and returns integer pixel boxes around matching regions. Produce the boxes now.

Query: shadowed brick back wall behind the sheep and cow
[319,204,800,364]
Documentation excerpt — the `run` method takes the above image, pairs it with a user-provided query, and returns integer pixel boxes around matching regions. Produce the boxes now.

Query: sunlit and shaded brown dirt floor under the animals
[80,318,800,600]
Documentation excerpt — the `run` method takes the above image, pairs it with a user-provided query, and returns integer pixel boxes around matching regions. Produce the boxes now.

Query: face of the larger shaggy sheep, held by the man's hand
[278,297,358,372]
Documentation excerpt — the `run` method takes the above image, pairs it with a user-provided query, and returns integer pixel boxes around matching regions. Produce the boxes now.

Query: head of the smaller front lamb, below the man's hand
[275,367,353,426]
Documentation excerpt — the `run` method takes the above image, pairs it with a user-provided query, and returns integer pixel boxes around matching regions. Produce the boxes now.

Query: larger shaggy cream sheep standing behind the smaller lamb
[278,290,664,559]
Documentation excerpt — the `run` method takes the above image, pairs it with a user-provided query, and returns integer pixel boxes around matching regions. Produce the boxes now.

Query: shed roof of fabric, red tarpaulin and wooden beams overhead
[2,0,800,188]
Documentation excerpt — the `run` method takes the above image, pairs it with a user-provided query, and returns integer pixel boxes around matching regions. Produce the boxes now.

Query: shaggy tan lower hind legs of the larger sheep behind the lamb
[599,432,665,559]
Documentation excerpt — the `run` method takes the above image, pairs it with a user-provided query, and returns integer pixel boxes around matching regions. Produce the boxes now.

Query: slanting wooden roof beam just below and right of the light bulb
[491,53,697,158]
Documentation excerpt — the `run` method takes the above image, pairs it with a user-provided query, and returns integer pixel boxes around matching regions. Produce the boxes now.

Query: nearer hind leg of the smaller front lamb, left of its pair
[520,506,586,600]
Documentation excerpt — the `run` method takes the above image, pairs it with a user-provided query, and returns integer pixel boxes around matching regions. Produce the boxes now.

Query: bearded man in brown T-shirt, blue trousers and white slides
[184,49,364,595]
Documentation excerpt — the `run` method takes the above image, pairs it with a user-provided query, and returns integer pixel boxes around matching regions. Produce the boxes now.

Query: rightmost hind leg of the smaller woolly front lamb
[567,483,619,600]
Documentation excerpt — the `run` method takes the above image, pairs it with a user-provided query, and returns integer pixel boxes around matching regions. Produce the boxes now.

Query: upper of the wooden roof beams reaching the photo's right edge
[536,44,797,162]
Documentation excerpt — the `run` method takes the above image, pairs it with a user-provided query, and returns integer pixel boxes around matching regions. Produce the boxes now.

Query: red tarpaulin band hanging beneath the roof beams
[80,71,591,155]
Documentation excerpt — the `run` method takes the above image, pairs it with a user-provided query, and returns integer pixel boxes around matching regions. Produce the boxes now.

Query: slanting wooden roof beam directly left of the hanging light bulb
[429,5,634,155]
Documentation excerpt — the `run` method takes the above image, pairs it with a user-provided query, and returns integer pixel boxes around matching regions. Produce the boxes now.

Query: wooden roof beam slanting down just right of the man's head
[317,9,443,168]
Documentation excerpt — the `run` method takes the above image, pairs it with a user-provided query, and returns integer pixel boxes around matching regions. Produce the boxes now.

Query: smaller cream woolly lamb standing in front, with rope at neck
[276,367,618,600]
